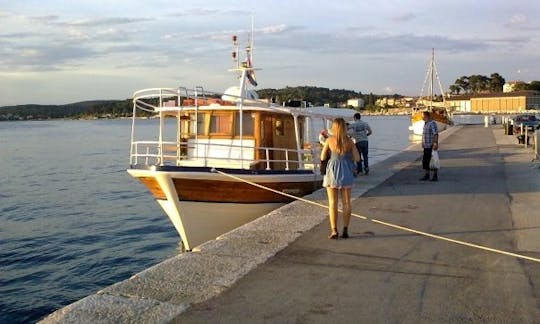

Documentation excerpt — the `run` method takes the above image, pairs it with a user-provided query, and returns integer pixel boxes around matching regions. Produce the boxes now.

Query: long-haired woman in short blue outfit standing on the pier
[321,118,360,239]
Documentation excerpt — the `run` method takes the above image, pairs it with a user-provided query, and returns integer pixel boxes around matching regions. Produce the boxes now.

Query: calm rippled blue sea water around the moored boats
[0,116,474,323]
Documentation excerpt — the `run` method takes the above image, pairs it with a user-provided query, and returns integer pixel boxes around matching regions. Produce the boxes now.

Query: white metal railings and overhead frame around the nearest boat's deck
[130,87,334,170]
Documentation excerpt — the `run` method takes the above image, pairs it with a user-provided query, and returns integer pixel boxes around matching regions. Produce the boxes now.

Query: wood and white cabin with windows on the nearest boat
[131,95,313,170]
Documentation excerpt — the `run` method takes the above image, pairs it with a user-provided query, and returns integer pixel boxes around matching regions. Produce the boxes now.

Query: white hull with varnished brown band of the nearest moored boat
[128,168,322,250]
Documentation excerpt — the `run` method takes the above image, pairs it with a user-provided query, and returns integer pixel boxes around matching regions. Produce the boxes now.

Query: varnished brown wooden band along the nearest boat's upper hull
[137,177,322,204]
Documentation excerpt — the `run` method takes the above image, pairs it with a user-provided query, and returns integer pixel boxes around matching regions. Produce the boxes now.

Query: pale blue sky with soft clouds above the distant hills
[0,0,540,106]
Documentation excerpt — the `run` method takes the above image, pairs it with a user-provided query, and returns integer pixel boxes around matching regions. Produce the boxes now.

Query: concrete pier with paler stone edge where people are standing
[42,125,540,323]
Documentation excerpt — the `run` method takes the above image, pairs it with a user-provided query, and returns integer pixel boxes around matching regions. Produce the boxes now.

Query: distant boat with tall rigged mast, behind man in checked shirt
[409,49,454,135]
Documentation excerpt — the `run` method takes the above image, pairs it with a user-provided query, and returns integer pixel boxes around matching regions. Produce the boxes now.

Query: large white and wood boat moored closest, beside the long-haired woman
[127,31,355,251]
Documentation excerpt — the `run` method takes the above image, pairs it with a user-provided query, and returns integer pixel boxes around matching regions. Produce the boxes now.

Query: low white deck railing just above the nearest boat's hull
[130,141,320,170]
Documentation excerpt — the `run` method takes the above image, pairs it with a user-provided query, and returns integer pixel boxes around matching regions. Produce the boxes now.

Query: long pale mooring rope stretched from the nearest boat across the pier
[212,168,540,262]
